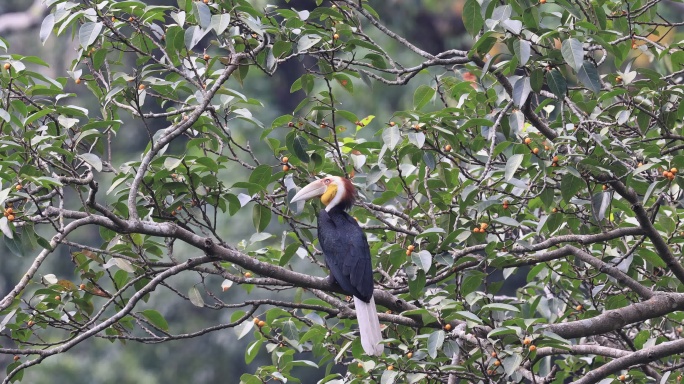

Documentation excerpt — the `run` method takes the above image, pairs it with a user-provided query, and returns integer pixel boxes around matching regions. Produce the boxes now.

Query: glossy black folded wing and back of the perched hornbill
[318,209,373,302]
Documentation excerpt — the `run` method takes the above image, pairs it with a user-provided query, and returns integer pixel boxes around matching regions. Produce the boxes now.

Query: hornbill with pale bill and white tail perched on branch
[291,176,383,356]
